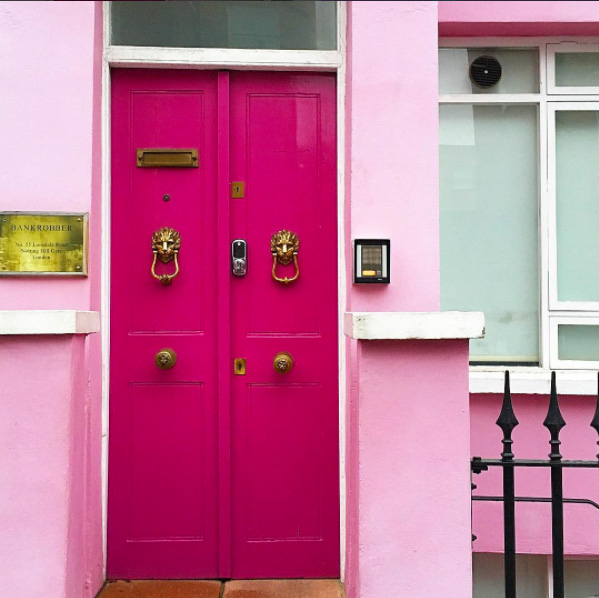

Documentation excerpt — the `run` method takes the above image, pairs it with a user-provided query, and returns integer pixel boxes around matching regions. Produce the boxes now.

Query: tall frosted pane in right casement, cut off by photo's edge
[556,110,599,301]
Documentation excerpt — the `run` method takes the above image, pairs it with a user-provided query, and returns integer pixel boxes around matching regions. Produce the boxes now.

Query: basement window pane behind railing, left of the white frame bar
[472,552,548,598]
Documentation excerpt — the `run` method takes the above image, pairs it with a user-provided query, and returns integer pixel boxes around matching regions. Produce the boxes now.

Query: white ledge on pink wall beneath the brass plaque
[0,309,100,336]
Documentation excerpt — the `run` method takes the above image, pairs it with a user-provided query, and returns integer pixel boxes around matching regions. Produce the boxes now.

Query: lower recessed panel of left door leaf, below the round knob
[127,383,206,540]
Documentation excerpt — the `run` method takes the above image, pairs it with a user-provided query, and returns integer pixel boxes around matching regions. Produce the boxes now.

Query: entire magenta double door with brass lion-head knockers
[108,70,339,579]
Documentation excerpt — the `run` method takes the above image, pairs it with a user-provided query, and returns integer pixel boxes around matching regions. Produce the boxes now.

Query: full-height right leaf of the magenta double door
[230,73,339,578]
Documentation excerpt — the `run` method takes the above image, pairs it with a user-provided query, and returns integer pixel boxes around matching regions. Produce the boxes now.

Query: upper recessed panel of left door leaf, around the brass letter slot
[123,89,207,333]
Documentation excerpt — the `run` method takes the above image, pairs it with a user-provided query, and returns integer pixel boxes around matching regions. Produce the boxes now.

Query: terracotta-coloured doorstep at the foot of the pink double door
[97,579,345,598]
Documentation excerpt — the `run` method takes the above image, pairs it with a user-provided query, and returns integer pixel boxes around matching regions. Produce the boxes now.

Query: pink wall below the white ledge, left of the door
[0,336,90,598]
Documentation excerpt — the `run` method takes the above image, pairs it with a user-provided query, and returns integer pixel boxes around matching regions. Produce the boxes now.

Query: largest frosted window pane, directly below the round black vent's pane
[440,105,539,363]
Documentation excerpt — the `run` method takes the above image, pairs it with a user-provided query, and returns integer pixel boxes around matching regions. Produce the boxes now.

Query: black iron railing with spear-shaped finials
[471,372,599,598]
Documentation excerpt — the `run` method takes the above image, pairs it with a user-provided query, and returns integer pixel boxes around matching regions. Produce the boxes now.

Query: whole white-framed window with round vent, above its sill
[439,39,599,369]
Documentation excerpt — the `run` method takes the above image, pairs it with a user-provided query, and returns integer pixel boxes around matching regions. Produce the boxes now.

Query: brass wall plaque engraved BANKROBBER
[0,212,88,276]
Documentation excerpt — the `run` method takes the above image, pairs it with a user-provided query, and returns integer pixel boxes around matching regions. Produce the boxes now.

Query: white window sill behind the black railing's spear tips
[470,366,597,396]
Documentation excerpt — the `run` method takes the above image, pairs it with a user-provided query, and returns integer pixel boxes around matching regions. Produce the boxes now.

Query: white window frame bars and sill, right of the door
[439,37,599,395]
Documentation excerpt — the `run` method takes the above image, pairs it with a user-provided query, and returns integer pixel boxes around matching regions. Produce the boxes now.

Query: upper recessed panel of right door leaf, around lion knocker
[244,94,326,335]
